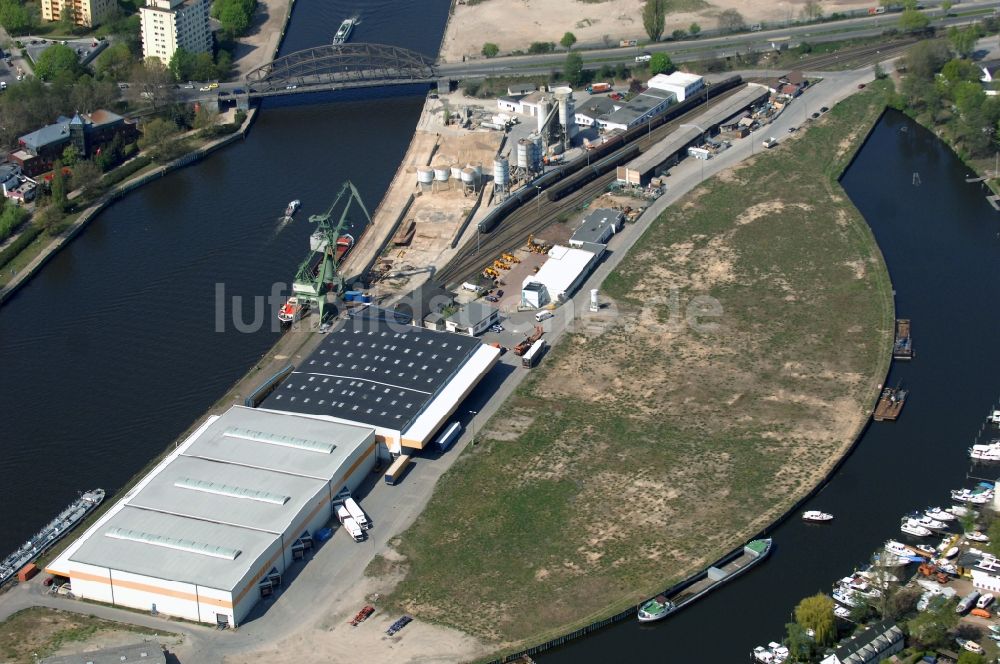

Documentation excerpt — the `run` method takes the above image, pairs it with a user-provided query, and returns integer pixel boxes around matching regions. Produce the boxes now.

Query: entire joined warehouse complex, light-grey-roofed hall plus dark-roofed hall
[45,308,499,627]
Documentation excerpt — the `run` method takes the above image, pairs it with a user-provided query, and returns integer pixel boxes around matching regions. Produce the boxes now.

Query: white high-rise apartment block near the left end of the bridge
[139,0,212,64]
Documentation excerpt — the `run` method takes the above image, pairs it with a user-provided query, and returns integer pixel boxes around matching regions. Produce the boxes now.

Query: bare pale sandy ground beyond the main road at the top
[440,0,878,62]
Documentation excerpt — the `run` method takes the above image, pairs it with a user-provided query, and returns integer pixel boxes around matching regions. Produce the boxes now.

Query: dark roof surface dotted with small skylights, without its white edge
[262,318,480,431]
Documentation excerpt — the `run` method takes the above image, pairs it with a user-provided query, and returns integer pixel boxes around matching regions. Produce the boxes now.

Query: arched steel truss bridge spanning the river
[244,43,437,97]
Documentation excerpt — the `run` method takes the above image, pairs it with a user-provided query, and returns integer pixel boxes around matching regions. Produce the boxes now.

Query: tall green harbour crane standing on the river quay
[292,180,372,321]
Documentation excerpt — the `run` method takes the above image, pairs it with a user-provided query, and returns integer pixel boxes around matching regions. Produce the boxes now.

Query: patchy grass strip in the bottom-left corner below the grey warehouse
[0,607,173,664]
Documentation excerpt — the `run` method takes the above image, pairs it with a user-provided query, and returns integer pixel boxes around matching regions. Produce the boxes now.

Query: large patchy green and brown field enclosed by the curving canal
[369,80,893,650]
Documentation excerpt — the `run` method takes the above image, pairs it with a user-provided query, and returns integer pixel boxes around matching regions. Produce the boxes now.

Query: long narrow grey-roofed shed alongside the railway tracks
[617,83,770,187]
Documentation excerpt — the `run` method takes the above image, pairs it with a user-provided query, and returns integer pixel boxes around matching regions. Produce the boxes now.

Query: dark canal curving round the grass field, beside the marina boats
[537,111,1000,664]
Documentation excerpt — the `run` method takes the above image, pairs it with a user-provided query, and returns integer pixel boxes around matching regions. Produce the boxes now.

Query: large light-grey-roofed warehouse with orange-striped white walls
[46,407,377,625]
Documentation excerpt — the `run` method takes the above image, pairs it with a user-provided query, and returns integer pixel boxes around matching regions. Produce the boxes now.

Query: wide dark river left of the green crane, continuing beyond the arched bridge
[0,0,448,557]
